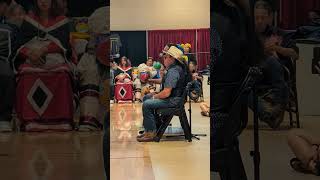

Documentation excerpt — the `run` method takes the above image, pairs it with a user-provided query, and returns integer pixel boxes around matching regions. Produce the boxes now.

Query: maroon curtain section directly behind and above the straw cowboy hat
[148,30,196,62]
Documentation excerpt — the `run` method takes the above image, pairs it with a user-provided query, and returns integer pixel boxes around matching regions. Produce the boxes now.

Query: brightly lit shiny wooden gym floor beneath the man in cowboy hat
[110,76,210,180]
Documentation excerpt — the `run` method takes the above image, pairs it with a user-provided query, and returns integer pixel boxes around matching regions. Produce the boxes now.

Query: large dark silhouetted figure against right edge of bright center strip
[210,0,260,180]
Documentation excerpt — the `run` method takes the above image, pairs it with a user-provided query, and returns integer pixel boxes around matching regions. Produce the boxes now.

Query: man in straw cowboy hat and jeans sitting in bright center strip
[137,46,187,142]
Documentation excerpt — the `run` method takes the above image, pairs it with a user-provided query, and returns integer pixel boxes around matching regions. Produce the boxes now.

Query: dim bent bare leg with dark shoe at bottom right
[288,129,320,176]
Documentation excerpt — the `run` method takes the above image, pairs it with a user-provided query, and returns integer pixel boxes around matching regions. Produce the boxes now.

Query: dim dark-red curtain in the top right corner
[280,0,320,29]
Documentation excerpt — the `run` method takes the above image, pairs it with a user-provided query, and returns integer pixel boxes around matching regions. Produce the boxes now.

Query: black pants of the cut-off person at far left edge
[0,74,15,121]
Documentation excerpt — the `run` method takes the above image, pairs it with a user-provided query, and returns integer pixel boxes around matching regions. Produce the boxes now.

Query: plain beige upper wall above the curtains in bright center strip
[110,0,210,31]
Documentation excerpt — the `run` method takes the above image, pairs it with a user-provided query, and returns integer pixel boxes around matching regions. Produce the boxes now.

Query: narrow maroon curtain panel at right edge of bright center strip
[197,29,210,70]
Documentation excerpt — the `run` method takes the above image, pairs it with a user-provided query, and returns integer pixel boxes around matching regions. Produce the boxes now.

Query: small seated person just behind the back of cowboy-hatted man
[189,61,203,99]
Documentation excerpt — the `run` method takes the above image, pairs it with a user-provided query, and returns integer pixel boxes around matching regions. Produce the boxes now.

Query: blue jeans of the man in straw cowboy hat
[142,94,175,132]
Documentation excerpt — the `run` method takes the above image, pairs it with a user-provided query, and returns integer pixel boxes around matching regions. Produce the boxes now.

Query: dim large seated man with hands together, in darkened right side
[250,1,297,129]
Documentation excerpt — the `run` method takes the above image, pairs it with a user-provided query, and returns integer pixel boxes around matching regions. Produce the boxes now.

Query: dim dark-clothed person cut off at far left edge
[0,0,15,132]
